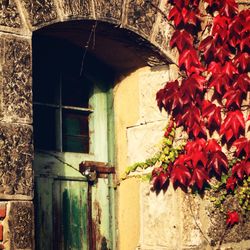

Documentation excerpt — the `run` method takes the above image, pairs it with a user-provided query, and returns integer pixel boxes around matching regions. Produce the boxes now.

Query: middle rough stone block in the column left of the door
[0,122,33,199]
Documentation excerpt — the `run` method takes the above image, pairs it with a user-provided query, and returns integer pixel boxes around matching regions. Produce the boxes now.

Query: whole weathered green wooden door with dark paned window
[33,36,114,250]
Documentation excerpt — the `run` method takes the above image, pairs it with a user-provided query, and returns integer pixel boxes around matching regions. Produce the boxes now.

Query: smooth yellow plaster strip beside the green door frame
[114,68,148,250]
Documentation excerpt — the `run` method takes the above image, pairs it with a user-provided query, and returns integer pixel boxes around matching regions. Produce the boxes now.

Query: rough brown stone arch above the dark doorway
[0,0,173,63]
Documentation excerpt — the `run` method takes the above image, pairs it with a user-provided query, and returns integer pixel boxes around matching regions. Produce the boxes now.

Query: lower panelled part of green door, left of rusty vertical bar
[36,177,89,250]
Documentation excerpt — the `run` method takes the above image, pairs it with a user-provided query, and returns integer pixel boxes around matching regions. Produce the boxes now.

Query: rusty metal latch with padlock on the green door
[79,161,115,182]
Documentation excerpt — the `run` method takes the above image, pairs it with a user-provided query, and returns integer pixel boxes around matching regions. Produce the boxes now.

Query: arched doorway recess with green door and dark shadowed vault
[33,21,172,250]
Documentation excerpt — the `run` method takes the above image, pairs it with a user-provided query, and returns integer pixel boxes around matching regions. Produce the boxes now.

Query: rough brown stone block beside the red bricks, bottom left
[8,201,34,250]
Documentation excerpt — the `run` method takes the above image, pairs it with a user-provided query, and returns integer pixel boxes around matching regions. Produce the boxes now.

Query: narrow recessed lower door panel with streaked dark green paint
[53,180,88,250]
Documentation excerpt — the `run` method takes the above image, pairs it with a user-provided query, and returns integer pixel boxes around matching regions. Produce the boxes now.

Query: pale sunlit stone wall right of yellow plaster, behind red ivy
[125,58,250,250]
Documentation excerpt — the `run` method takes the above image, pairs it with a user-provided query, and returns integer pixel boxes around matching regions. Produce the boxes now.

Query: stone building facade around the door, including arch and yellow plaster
[0,0,250,250]
